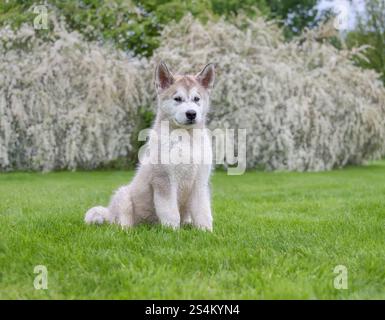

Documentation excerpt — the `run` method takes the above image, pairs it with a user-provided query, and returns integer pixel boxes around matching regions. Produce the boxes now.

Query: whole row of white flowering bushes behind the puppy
[0,16,385,171]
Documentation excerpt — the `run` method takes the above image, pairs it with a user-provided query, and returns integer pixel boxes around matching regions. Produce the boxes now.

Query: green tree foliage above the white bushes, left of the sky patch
[0,0,324,56]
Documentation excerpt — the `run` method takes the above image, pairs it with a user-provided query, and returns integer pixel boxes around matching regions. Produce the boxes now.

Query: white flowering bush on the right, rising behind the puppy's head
[154,16,385,171]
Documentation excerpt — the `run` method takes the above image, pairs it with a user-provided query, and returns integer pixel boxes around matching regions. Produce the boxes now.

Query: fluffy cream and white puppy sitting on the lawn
[85,62,215,231]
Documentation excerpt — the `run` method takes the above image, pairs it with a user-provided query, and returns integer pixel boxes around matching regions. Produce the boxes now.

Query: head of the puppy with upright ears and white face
[155,62,215,128]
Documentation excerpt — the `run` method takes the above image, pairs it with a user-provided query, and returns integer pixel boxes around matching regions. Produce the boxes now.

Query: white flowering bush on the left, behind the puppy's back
[0,22,150,171]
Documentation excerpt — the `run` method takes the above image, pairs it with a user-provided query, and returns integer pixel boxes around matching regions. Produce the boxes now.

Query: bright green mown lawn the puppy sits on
[0,162,385,299]
